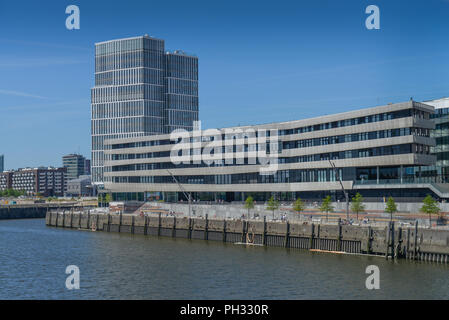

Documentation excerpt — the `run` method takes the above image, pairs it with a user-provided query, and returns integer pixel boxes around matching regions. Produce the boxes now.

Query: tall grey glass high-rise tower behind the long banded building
[91,35,198,184]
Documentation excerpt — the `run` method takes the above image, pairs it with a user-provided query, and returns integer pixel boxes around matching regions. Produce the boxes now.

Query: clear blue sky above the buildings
[0,0,449,168]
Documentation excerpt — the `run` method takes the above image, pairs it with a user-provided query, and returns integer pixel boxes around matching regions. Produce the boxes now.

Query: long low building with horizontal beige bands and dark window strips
[100,100,449,201]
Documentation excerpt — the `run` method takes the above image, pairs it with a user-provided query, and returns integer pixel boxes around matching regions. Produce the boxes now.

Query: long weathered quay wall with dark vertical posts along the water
[46,210,449,263]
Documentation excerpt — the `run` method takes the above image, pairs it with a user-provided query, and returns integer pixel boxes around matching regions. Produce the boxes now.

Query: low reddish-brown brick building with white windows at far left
[0,167,67,197]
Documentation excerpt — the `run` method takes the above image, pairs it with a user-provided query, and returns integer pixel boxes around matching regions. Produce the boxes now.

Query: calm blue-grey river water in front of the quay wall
[0,220,449,299]
